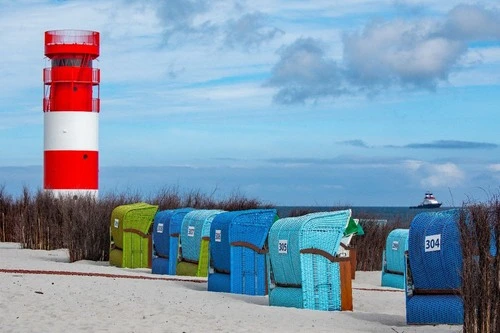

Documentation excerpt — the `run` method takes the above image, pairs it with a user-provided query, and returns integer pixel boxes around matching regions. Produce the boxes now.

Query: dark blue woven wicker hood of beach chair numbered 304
[408,210,462,289]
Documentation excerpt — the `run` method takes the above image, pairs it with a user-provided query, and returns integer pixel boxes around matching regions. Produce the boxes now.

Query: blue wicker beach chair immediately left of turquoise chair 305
[208,209,277,295]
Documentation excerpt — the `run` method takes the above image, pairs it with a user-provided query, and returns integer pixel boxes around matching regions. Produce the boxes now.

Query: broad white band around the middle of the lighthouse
[44,111,99,150]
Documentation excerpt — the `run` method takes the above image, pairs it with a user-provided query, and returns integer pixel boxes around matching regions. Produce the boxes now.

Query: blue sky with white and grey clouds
[0,0,500,206]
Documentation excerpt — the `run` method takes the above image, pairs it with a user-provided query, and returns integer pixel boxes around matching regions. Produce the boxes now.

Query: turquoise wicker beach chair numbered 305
[268,209,352,311]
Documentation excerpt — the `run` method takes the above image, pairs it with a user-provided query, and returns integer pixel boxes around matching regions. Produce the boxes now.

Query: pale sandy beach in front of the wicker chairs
[0,243,462,333]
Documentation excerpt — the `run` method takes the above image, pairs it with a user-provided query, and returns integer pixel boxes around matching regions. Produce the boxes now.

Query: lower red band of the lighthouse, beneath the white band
[43,150,99,190]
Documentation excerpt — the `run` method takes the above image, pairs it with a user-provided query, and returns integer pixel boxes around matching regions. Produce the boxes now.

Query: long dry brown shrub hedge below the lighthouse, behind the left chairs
[0,187,270,262]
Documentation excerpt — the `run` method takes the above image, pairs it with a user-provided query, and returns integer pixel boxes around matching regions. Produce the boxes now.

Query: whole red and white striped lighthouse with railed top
[43,30,100,196]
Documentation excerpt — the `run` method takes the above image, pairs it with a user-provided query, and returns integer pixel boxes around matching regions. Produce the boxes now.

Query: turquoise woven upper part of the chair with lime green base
[180,209,223,262]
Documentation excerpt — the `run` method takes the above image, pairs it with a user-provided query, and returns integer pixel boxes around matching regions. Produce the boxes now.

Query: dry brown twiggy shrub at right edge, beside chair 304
[459,198,500,333]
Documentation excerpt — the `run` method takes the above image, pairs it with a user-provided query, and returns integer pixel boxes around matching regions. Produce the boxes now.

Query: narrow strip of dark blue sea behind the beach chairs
[276,206,452,226]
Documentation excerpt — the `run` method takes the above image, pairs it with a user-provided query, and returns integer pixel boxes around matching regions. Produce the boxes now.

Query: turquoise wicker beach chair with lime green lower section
[176,209,224,277]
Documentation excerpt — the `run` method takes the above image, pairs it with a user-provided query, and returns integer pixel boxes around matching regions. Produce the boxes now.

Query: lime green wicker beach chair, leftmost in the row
[109,202,158,268]
